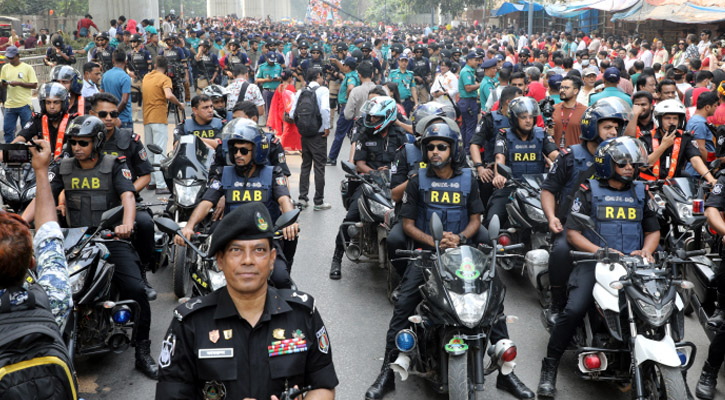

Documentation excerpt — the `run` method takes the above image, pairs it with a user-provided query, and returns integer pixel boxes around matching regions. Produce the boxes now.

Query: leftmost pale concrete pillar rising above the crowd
[88,0,160,31]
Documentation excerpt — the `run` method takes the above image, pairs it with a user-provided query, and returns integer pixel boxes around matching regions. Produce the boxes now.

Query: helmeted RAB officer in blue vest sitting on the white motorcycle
[537,136,660,398]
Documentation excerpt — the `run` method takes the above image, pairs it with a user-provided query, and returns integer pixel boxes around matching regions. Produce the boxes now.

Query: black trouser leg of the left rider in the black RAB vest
[104,241,151,343]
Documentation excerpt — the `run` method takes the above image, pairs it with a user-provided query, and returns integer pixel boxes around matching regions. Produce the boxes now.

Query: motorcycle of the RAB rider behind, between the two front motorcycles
[498,164,551,307]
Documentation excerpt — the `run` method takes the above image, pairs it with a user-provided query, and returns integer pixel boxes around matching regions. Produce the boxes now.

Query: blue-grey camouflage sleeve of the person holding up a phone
[0,221,73,327]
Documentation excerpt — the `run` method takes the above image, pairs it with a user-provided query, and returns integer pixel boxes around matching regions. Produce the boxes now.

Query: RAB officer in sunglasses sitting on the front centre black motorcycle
[365,122,534,400]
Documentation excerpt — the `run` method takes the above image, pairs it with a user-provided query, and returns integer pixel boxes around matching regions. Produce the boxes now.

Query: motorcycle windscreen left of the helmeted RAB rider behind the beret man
[161,135,213,181]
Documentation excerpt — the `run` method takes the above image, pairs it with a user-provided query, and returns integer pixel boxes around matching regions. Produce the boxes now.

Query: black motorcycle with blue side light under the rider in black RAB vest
[62,206,140,359]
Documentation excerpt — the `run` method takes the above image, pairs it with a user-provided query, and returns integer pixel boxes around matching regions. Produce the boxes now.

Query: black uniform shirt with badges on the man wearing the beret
[156,287,338,400]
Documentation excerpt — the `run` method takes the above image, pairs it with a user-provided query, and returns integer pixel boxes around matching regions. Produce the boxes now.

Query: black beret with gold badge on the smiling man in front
[209,202,274,256]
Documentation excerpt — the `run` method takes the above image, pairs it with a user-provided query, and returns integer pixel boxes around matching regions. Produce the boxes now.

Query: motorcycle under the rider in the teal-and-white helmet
[340,161,399,296]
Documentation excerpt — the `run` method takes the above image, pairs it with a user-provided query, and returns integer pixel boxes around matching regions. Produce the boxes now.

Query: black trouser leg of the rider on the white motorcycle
[546,262,596,360]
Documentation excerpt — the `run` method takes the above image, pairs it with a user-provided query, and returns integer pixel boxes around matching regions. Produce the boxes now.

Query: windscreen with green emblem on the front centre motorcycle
[441,246,491,294]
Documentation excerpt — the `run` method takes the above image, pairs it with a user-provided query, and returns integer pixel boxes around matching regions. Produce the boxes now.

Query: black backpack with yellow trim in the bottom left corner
[0,285,78,400]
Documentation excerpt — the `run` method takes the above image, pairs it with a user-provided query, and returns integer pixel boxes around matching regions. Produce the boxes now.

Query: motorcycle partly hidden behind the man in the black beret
[154,209,300,298]
